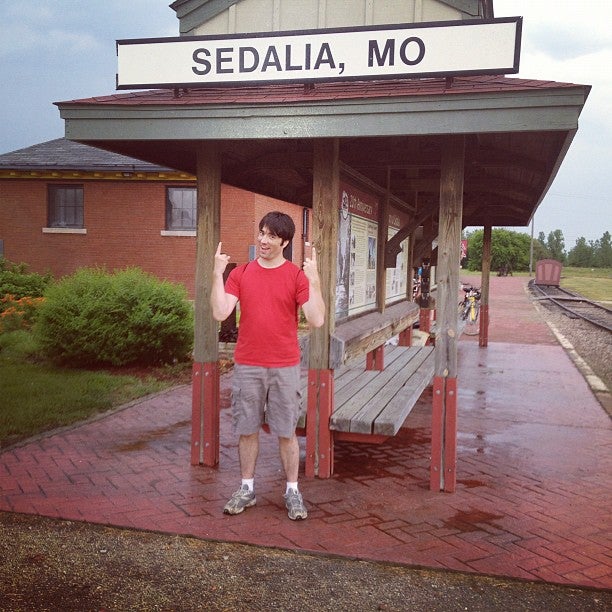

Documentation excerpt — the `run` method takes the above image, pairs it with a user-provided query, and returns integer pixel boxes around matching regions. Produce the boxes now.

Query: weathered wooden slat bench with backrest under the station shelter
[298,301,434,442]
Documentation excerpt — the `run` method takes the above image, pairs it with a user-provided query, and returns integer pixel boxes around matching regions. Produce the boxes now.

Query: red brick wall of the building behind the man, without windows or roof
[0,179,302,297]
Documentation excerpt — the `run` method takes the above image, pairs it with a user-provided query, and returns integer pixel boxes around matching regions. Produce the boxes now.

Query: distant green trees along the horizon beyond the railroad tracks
[461,228,612,272]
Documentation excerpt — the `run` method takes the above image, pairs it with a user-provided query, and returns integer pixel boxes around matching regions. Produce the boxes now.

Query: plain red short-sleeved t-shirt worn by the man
[225,260,309,368]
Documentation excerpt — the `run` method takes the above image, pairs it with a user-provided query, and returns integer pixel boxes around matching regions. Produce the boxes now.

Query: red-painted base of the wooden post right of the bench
[429,376,457,493]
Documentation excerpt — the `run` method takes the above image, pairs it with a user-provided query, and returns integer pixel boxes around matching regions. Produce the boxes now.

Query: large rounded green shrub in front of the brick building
[34,268,193,366]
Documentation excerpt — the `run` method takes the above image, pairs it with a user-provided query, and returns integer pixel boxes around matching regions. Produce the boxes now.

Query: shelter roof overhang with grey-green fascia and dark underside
[58,77,590,226]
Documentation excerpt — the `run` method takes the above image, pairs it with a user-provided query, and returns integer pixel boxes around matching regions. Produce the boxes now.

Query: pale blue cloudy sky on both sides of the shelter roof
[0,0,612,249]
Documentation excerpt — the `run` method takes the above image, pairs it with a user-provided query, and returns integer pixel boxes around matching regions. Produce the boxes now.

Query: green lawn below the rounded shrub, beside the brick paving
[0,331,180,449]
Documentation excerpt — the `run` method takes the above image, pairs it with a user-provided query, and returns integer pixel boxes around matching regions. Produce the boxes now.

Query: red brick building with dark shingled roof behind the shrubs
[0,138,307,297]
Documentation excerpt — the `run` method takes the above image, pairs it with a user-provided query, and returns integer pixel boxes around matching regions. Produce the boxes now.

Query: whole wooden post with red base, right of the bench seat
[430,136,465,492]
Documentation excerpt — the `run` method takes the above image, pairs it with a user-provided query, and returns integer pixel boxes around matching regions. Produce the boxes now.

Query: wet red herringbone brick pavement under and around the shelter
[0,277,612,588]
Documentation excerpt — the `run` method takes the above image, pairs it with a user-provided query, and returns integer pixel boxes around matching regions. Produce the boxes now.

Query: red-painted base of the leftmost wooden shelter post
[191,361,219,467]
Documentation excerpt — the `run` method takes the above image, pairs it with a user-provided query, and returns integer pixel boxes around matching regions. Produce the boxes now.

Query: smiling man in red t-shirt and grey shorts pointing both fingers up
[210,211,325,520]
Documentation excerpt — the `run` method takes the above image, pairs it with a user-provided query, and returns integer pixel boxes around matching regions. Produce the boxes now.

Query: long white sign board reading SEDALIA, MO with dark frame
[117,17,522,89]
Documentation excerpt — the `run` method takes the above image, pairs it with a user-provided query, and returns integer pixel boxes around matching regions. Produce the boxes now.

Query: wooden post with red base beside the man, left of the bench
[306,138,340,478]
